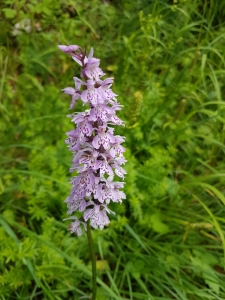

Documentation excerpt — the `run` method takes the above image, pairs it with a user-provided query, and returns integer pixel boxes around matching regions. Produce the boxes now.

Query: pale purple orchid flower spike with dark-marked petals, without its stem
[58,45,126,236]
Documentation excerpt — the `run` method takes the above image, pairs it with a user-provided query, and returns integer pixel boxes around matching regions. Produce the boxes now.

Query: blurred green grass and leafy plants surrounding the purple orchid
[0,0,225,300]
